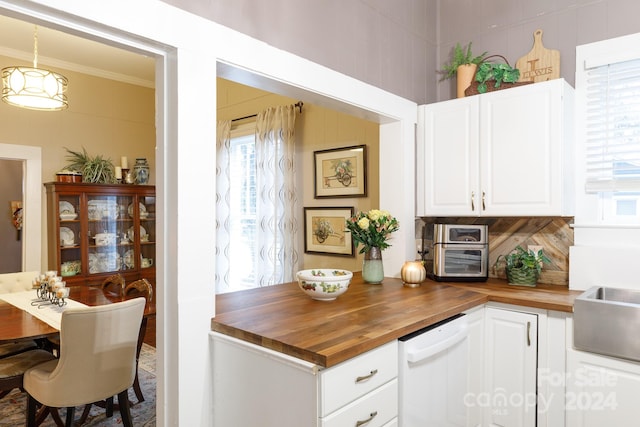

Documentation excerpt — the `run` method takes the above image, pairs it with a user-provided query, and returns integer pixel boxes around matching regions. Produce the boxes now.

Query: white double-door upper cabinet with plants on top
[416,79,575,216]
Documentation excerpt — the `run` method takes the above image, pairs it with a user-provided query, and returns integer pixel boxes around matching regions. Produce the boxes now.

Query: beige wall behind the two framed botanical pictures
[217,79,380,271]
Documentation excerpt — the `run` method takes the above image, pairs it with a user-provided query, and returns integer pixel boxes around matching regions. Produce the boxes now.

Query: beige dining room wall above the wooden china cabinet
[0,56,156,270]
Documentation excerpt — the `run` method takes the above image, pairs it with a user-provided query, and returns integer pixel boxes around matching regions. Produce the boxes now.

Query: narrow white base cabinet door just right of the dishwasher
[484,307,538,427]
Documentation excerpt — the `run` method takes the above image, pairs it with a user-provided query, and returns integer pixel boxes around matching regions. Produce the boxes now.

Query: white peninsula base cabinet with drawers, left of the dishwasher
[210,332,398,427]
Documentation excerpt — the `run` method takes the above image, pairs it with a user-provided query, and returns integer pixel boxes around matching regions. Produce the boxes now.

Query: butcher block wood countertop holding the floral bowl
[211,273,580,367]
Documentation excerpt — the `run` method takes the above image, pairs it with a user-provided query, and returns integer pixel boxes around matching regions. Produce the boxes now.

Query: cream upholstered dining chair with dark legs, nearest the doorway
[23,298,145,426]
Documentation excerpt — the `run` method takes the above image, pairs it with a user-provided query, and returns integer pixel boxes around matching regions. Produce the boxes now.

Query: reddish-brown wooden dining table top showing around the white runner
[0,286,156,343]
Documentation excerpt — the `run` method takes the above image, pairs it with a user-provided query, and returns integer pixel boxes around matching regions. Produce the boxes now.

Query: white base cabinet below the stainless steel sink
[563,320,640,427]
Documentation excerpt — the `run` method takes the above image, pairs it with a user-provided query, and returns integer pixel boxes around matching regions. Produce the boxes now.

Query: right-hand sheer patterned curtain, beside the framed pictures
[256,105,298,286]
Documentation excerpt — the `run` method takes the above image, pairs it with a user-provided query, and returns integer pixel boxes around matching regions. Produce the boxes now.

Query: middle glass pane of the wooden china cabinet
[86,195,136,274]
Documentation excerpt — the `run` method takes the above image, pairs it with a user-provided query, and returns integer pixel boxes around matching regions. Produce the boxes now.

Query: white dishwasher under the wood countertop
[398,308,483,427]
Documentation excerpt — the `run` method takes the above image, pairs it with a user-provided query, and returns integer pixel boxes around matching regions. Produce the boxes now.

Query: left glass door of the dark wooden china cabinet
[57,194,82,277]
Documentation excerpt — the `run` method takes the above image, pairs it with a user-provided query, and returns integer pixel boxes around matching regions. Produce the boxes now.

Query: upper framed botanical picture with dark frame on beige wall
[313,145,367,199]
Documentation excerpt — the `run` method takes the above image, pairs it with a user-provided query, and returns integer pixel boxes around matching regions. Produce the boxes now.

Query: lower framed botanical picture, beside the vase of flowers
[304,207,354,256]
